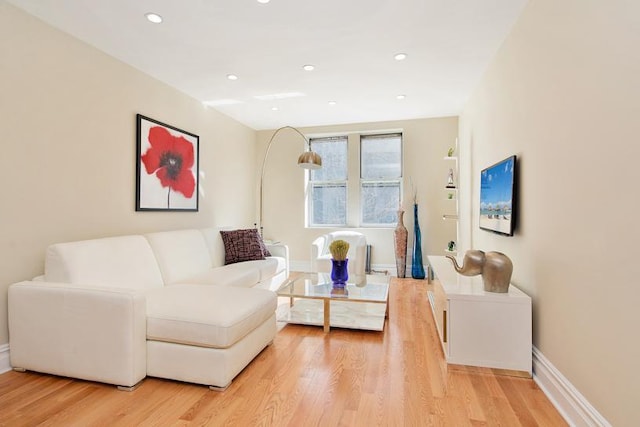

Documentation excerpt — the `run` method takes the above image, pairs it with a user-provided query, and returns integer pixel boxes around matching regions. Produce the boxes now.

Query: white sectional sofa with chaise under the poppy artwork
[9,228,289,389]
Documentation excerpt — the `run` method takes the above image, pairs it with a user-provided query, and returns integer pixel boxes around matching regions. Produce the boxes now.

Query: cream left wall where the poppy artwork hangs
[0,1,255,347]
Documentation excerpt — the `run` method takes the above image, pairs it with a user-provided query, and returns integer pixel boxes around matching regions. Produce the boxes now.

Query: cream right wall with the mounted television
[460,0,640,426]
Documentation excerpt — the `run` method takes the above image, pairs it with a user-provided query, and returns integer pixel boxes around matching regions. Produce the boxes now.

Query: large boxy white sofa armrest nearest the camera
[8,281,147,387]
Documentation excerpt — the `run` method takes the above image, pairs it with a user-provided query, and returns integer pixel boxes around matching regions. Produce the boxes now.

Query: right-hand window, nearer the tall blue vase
[360,133,402,226]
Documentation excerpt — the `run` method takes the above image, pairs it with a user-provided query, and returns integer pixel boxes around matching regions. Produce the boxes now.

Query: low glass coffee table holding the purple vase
[277,273,389,332]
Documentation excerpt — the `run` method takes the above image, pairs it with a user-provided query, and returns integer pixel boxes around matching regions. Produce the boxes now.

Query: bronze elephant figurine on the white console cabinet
[447,249,513,293]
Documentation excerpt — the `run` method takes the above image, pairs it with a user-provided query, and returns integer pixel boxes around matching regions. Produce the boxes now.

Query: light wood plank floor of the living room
[0,279,566,427]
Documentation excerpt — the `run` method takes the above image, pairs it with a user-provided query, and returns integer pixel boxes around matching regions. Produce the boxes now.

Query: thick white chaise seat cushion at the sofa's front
[147,284,277,348]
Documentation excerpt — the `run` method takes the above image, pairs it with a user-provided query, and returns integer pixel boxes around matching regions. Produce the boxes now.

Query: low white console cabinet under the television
[428,256,532,377]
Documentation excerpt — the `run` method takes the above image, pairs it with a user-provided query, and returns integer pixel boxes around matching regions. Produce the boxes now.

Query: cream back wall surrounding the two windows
[256,117,458,275]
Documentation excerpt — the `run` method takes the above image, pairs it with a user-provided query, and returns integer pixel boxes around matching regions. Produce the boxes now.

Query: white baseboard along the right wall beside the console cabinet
[533,346,611,427]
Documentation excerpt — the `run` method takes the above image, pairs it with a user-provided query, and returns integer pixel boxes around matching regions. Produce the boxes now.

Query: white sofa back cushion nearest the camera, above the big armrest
[44,235,163,289]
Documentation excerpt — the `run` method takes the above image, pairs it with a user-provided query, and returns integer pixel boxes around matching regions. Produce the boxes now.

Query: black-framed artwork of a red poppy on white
[136,114,200,211]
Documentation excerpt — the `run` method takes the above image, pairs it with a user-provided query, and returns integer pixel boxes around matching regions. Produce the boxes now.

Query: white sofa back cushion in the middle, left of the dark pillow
[145,230,212,285]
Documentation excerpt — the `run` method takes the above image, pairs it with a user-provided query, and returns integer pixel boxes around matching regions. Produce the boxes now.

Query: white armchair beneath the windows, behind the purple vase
[311,231,367,277]
